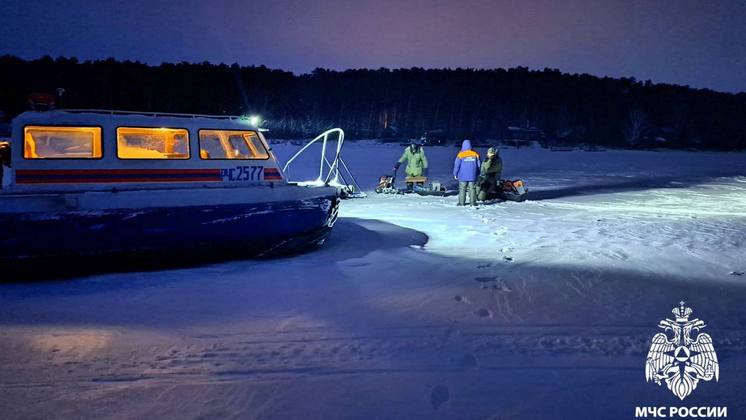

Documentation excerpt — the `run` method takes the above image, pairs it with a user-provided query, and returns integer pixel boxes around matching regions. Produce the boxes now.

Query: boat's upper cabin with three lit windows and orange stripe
[3,110,285,191]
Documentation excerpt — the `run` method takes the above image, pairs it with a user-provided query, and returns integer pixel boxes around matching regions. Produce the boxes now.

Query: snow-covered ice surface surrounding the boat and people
[0,143,746,419]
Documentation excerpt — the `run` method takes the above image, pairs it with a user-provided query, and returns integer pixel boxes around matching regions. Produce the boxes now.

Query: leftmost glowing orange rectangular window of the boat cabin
[23,125,102,159]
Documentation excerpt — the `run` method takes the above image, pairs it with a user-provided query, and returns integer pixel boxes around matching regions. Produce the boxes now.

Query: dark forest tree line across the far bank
[0,55,746,150]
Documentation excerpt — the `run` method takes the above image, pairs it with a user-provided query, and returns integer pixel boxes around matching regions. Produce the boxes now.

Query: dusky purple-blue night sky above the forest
[0,0,746,92]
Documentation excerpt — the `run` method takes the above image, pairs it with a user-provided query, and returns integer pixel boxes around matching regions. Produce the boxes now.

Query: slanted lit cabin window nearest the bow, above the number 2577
[199,130,269,159]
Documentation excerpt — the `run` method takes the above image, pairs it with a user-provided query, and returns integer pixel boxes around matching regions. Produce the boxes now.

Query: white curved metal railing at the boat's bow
[282,128,367,198]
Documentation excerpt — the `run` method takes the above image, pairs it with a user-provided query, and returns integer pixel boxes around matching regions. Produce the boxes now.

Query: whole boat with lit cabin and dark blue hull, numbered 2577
[0,110,339,274]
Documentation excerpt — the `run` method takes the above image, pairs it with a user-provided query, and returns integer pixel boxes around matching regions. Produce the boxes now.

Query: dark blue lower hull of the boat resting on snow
[0,195,339,275]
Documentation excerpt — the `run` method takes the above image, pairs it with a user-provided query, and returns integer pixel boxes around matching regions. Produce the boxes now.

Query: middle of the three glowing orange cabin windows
[117,127,189,159]
